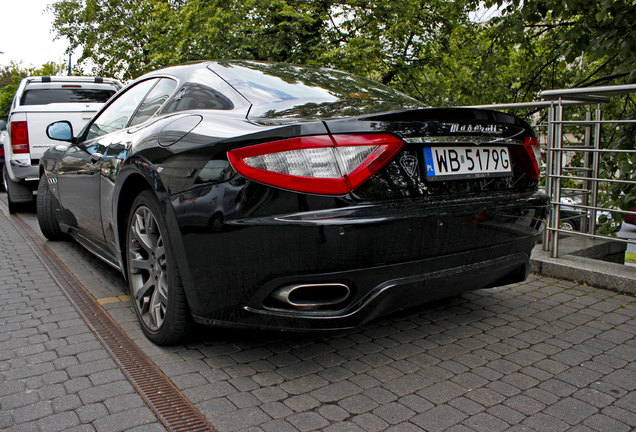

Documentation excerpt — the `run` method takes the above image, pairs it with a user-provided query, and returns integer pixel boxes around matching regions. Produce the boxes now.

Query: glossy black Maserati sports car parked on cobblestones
[38,61,547,344]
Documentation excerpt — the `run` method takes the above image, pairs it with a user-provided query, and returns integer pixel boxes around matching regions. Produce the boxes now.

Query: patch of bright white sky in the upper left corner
[0,0,74,67]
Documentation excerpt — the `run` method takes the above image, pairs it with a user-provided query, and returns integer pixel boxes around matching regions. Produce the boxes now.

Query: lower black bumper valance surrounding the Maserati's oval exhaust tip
[194,245,529,331]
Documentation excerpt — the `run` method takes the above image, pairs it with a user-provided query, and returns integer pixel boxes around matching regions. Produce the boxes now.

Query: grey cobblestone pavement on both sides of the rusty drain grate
[0,203,636,432]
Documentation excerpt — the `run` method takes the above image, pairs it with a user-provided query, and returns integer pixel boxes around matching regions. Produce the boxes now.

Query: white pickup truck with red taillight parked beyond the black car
[3,76,122,213]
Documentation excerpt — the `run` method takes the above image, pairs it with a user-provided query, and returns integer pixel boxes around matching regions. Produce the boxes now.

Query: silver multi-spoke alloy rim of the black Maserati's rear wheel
[128,205,168,331]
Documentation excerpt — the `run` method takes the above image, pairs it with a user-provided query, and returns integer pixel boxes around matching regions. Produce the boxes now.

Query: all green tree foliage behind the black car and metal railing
[51,0,636,105]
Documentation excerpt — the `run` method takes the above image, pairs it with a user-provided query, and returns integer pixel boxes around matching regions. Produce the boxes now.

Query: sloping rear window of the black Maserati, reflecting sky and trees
[214,61,423,117]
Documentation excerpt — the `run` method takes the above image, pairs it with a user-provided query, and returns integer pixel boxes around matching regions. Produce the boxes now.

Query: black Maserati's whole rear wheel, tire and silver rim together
[126,190,192,345]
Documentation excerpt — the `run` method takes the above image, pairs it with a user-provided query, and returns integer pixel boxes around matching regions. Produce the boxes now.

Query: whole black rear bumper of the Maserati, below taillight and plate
[173,190,547,330]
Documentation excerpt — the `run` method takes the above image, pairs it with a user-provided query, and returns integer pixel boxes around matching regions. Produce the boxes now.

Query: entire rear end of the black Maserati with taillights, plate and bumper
[173,109,547,330]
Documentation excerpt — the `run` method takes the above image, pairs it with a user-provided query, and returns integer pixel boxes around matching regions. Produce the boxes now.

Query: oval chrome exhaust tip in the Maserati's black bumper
[270,283,351,311]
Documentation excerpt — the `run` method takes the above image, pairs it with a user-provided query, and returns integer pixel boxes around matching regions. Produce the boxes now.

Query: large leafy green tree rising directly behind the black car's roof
[52,0,477,87]
